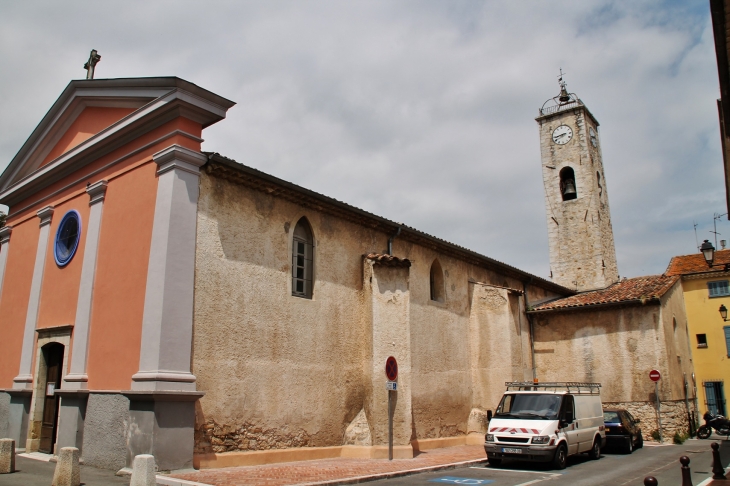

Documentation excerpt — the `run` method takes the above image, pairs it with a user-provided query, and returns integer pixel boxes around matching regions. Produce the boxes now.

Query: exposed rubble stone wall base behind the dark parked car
[603,400,692,442]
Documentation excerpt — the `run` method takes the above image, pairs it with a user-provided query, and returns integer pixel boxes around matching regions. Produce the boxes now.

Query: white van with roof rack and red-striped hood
[484,382,606,469]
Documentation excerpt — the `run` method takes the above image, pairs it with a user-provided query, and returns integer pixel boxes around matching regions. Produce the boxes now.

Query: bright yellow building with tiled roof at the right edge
[666,250,730,415]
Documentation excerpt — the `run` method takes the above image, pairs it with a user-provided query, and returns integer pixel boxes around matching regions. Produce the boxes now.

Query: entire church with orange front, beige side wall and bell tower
[0,77,692,470]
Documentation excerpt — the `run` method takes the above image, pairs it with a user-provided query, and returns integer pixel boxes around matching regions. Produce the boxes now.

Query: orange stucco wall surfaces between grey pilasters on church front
[0,112,202,390]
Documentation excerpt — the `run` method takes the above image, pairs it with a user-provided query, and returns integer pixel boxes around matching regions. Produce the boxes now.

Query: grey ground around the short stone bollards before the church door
[0,455,129,486]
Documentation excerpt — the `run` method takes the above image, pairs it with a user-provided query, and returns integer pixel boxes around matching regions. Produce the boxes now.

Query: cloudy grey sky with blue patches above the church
[0,0,730,277]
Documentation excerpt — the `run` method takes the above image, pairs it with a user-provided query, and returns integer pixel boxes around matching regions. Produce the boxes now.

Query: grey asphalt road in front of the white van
[370,440,730,486]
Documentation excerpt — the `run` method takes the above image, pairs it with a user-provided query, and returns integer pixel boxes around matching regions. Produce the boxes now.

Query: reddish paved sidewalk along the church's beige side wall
[172,445,487,486]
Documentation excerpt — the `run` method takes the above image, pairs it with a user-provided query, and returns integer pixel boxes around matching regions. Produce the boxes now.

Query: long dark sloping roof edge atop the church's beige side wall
[204,152,575,295]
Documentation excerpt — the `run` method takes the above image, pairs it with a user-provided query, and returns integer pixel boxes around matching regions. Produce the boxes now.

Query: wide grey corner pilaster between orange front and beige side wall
[132,145,203,390]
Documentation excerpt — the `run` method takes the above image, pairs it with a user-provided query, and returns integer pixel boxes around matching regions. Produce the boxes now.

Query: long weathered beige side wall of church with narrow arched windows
[192,173,556,454]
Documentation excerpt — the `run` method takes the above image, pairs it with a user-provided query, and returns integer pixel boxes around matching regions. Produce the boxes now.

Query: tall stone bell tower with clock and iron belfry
[535,71,618,292]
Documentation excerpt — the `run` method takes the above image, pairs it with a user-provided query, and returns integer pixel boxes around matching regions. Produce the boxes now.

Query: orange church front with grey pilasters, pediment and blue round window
[0,78,233,469]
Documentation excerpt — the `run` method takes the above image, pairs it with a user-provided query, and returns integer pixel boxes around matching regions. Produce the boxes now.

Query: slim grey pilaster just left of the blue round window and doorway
[13,206,53,389]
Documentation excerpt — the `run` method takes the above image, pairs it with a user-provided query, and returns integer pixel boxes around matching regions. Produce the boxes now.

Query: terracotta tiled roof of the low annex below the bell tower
[529,275,679,312]
